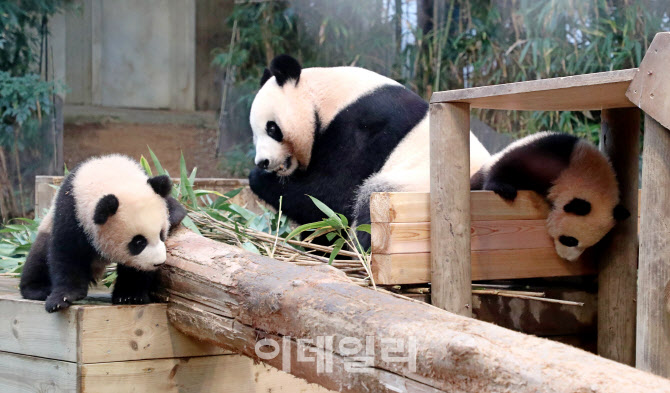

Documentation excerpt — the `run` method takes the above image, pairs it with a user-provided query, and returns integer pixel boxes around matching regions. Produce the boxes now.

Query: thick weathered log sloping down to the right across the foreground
[161,230,670,393]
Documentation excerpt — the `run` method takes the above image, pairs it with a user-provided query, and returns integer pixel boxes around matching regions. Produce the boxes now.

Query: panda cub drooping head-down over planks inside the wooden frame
[470,132,630,261]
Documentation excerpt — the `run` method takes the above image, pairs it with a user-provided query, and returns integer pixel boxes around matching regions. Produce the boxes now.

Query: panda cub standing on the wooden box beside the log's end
[20,155,186,312]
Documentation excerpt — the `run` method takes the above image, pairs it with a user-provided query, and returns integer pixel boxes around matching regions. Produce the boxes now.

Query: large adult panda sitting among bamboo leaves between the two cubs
[249,55,490,248]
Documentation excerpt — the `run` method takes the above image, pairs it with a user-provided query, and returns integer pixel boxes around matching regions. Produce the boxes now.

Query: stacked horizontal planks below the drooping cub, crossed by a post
[370,191,596,285]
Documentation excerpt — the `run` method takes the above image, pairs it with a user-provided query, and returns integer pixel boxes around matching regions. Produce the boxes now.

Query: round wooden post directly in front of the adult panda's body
[430,103,472,316]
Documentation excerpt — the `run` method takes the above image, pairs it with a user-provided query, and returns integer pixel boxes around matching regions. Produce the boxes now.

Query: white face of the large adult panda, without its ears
[249,78,315,176]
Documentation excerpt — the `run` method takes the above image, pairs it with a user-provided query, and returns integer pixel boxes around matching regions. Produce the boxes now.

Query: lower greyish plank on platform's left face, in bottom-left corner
[0,352,79,393]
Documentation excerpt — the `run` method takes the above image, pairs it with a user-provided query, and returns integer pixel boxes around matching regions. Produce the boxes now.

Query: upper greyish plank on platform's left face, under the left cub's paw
[0,294,81,362]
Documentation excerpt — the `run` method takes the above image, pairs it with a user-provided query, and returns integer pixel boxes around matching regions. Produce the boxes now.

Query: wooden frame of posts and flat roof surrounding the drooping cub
[420,29,670,376]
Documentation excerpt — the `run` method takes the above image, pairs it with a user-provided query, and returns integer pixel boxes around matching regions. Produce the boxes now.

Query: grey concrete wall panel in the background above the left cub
[51,0,196,110]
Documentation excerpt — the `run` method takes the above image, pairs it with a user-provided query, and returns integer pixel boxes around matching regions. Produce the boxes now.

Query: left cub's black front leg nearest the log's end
[112,264,156,304]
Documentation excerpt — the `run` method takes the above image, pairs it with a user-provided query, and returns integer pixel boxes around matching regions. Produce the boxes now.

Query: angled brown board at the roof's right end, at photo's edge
[626,32,670,128]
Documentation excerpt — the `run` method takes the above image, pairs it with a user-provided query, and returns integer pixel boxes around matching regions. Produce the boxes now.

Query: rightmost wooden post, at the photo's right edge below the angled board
[636,115,670,378]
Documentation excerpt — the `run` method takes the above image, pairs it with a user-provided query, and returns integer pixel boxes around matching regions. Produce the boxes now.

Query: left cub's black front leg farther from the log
[44,248,92,313]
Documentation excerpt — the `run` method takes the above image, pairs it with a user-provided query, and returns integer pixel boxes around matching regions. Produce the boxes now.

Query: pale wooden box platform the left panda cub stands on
[0,277,328,393]
